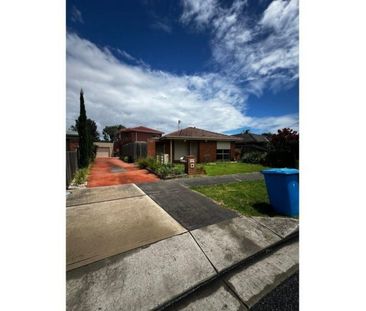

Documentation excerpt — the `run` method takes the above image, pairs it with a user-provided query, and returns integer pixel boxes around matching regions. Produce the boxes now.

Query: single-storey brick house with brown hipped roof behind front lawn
[147,127,239,163]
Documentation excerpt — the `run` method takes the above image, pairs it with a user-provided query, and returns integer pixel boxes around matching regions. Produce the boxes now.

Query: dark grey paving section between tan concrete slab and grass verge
[138,182,239,230]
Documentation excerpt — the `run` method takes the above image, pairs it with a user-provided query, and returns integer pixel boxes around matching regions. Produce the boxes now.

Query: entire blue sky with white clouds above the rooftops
[66,0,299,134]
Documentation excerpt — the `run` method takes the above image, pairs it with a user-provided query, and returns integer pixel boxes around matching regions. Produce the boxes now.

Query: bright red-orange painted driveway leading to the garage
[87,158,159,188]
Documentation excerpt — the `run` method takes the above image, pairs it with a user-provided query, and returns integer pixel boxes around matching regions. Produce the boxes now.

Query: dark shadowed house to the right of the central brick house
[232,132,269,158]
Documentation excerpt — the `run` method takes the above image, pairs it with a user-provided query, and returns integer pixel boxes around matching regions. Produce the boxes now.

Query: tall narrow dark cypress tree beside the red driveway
[78,89,90,167]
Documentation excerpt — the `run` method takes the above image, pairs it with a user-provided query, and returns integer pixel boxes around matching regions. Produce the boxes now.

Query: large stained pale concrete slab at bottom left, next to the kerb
[66,233,215,311]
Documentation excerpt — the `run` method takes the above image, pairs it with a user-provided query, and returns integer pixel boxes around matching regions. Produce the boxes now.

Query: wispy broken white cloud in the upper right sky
[181,0,299,96]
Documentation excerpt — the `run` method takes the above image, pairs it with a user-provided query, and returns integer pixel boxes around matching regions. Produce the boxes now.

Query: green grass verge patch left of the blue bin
[192,180,275,216]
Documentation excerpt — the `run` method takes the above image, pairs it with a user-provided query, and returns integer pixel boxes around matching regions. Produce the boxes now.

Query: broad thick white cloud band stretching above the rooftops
[66,33,293,133]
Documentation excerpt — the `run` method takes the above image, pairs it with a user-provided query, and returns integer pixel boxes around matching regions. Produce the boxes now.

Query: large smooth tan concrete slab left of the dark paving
[66,195,186,270]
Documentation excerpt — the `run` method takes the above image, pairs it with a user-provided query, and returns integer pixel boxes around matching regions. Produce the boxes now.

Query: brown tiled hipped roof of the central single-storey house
[162,127,237,141]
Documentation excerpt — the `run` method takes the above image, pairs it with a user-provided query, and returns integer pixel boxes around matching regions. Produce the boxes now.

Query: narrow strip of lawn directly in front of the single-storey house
[204,163,265,176]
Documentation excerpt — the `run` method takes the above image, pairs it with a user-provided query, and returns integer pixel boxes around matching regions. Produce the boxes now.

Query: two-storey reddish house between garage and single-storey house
[116,126,163,162]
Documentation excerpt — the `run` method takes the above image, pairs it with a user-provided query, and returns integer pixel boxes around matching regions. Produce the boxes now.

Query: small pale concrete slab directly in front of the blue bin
[252,216,299,238]
